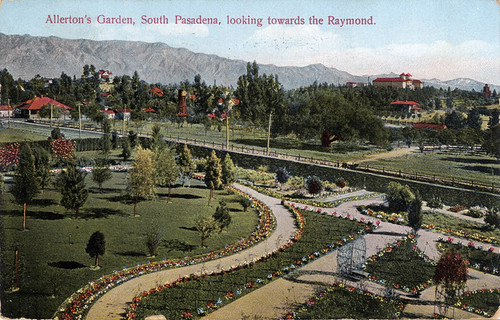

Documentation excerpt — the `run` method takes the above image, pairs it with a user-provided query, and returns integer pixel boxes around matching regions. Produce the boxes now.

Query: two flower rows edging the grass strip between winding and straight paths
[126,202,374,320]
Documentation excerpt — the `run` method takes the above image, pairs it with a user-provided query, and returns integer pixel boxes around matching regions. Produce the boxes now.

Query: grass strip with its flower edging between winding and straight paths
[127,206,371,319]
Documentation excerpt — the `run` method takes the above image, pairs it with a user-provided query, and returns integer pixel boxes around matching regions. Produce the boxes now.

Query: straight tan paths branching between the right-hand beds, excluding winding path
[203,195,500,320]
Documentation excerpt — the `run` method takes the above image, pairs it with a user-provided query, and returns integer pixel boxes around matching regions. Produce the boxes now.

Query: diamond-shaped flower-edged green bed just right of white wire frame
[365,234,436,294]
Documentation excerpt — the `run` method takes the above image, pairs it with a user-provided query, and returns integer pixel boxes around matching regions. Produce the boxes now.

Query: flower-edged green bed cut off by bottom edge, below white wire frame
[283,282,405,320]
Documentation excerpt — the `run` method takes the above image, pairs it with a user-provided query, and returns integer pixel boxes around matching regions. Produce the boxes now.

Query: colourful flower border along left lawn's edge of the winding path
[53,187,276,320]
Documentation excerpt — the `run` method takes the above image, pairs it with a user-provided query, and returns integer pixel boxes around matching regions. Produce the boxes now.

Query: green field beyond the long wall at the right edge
[362,151,500,186]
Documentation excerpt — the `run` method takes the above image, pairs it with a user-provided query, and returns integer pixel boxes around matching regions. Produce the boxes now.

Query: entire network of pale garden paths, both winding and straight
[82,185,500,320]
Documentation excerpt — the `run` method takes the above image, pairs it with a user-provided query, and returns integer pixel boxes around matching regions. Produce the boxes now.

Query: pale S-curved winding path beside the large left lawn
[85,185,297,320]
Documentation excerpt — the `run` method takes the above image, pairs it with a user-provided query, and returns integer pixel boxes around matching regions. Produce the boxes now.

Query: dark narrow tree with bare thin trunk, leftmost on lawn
[12,143,39,230]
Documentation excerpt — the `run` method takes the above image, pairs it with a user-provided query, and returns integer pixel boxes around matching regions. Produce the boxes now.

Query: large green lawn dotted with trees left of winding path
[0,173,257,318]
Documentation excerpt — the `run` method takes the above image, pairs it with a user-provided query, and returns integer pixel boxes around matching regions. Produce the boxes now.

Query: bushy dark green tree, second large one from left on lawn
[57,161,88,215]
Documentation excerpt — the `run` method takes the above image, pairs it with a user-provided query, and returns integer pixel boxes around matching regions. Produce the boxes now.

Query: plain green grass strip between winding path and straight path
[136,211,364,319]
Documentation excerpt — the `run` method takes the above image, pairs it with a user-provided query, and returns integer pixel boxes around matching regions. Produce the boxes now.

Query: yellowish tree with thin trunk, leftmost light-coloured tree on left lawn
[129,146,156,216]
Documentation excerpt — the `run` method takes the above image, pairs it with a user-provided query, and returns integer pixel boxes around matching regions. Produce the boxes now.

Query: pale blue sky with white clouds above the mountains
[0,0,500,84]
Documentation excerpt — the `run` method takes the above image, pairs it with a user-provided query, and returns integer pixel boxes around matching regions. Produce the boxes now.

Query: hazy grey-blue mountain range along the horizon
[0,33,500,92]
